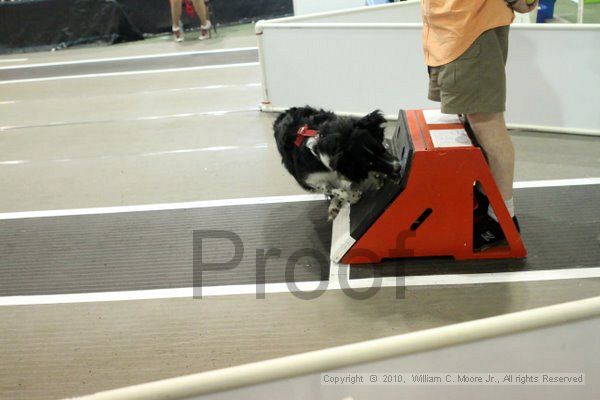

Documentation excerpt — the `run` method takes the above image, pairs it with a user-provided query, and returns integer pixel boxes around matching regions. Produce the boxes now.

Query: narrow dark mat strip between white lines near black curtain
[0,49,258,81]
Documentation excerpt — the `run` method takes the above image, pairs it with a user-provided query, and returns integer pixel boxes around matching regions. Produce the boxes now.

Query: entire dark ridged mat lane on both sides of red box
[0,185,600,296]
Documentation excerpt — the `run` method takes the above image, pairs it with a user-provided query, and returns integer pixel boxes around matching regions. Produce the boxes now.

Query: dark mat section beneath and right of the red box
[350,185,600,279]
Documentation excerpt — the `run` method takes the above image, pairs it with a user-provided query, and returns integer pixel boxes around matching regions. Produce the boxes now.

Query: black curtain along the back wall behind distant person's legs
[0,0,293,54]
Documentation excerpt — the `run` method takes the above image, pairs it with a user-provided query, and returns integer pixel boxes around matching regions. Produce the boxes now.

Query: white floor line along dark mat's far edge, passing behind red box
[0,177,600,220]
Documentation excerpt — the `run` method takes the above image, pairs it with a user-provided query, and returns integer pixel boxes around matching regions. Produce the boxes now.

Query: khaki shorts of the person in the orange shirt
[428,26,509,114]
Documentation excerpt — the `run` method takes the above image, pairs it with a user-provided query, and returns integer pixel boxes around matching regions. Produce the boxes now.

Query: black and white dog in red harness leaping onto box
[273,107,400,221]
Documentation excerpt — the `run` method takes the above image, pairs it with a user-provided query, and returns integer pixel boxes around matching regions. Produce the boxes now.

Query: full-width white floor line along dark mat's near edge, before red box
[0,267,600,307]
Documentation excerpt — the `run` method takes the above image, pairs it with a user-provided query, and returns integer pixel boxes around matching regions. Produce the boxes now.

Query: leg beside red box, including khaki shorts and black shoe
[438,26,518,250]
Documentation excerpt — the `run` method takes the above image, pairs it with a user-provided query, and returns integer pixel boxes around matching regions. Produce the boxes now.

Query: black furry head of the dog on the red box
[314,110,400,182]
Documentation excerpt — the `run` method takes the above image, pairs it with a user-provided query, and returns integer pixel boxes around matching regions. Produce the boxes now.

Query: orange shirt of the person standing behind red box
[421,0,515,67]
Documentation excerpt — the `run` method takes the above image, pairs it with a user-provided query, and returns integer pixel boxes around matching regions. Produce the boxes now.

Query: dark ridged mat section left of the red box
[0,201,331,296]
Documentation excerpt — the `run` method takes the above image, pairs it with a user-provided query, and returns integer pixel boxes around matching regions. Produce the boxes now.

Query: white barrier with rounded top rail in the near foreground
[68,297,600,400]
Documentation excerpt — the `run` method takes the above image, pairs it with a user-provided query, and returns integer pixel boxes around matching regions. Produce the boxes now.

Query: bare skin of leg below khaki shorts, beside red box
[467,113,515,201]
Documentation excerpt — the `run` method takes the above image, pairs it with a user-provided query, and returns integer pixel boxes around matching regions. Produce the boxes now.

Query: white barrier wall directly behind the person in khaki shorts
[256,2,600,135]
